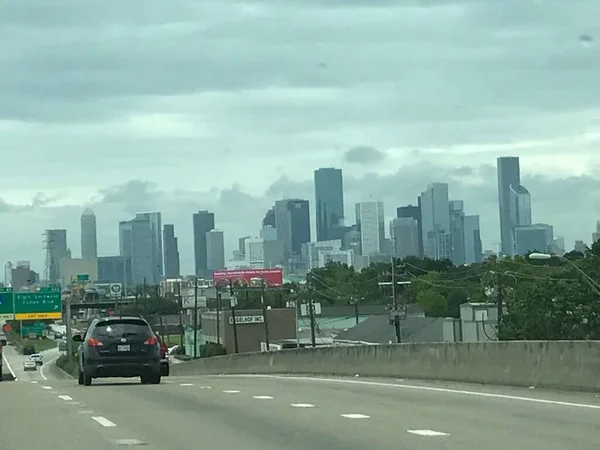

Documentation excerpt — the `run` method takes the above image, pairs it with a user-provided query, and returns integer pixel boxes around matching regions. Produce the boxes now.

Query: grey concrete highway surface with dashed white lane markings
[0,367,600,450]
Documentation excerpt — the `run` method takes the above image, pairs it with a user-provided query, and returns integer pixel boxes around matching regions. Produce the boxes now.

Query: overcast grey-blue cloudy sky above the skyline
[0,0,600,272]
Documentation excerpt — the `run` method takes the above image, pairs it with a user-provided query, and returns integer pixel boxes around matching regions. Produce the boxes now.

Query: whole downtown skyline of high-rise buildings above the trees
[5,157,600,289]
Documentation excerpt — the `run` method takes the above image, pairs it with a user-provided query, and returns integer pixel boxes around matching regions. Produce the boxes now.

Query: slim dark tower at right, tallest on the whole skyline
[497,156,521,256]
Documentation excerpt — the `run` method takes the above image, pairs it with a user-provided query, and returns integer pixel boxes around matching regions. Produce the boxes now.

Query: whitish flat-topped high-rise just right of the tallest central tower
[355,202,385,256]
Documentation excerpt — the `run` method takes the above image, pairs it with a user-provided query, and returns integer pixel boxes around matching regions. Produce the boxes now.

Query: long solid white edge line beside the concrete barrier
[225,375,600,410]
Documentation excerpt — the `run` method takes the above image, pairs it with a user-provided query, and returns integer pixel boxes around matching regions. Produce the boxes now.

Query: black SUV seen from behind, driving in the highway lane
[73,316,162,386]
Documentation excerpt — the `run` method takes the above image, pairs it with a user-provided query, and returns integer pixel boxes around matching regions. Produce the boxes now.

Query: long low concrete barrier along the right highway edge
[171,341,600,391]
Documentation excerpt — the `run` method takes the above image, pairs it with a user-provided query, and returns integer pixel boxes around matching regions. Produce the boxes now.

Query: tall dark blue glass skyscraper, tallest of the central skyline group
[314,167,344,241]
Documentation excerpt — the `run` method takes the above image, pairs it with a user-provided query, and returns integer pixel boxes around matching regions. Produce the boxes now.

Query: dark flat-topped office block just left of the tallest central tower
[275,199,310,259]
